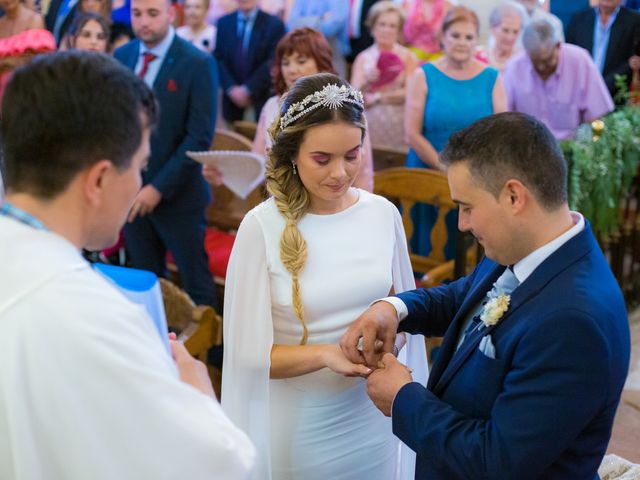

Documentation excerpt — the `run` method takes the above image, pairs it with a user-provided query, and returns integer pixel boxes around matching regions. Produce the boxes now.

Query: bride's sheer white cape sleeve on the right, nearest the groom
[392,202,429,479]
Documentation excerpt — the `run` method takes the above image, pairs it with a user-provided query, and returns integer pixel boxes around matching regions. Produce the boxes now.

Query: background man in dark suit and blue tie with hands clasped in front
[214,0,285,122]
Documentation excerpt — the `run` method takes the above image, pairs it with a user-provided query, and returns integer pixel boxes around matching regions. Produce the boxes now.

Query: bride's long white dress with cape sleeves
[222,190,426,480]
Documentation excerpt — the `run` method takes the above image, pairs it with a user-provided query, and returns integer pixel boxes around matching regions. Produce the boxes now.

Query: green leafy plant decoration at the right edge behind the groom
[562,105,640,235]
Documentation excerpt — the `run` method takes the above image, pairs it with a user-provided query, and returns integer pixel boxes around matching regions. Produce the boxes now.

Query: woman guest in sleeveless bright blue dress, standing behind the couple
[405,7,507,259]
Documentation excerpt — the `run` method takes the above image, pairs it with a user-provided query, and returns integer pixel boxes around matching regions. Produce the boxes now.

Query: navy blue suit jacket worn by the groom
[392,224,630,480]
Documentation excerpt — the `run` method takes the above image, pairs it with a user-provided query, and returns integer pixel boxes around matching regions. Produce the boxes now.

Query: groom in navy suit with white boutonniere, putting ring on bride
[341,113,630,480]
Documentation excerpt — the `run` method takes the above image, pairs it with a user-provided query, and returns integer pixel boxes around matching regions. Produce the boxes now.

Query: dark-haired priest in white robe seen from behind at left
[0,52,255,480]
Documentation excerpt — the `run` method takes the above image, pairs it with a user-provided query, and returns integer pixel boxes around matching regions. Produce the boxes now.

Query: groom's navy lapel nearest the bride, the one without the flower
[427,265,505,390]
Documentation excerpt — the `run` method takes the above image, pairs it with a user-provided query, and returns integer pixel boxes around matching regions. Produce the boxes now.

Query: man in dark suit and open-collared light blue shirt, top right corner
[567,0,640,98]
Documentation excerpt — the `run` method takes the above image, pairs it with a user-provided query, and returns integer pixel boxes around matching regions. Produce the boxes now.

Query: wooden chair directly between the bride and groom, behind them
[374,167,476,366]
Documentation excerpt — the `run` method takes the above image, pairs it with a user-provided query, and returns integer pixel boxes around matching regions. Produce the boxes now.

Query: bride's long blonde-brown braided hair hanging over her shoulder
[265,73,366,345]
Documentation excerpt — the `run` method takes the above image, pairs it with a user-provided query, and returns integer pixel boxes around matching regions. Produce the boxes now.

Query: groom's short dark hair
[440,112,567,210]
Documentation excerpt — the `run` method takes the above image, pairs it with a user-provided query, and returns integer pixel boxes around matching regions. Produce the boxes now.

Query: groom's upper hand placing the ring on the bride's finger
[340,302,398,368]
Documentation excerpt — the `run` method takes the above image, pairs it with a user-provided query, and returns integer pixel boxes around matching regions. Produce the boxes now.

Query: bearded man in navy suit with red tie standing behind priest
[115,0,218,306]
